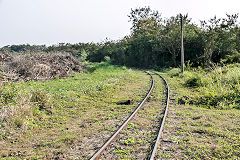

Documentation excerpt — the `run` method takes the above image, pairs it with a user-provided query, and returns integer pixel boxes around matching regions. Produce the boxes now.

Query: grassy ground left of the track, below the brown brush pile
[0,64,150,159]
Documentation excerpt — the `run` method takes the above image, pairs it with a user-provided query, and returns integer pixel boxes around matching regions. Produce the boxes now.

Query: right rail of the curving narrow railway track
[150,73,170,160]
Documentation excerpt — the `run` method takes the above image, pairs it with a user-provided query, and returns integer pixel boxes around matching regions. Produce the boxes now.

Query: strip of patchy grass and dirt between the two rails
[96,76,164,159]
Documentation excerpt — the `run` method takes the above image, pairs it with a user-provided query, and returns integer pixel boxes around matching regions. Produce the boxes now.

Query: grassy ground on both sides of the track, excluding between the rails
[0,64,240,159]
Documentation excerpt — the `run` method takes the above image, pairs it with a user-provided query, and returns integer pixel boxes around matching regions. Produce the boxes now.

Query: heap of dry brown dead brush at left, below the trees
[0,52,84,82]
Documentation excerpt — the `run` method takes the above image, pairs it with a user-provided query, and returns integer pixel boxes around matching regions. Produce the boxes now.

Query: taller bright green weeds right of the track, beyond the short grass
[162,64,240,109]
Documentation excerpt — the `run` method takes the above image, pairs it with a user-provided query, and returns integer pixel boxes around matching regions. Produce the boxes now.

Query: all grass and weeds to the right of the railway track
[159,64,240,159]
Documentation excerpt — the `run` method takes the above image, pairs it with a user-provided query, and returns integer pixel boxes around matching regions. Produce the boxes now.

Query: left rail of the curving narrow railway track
[90,72,154,160]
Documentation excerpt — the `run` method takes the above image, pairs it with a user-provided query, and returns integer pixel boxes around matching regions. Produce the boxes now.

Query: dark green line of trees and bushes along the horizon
[0,7,240,69]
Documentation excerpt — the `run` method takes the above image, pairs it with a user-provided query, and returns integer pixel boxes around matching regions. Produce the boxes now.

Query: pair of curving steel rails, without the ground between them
[91,72,169,160]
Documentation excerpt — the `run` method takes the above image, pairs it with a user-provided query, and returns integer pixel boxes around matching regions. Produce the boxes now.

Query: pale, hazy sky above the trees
[0,0,240,47]
